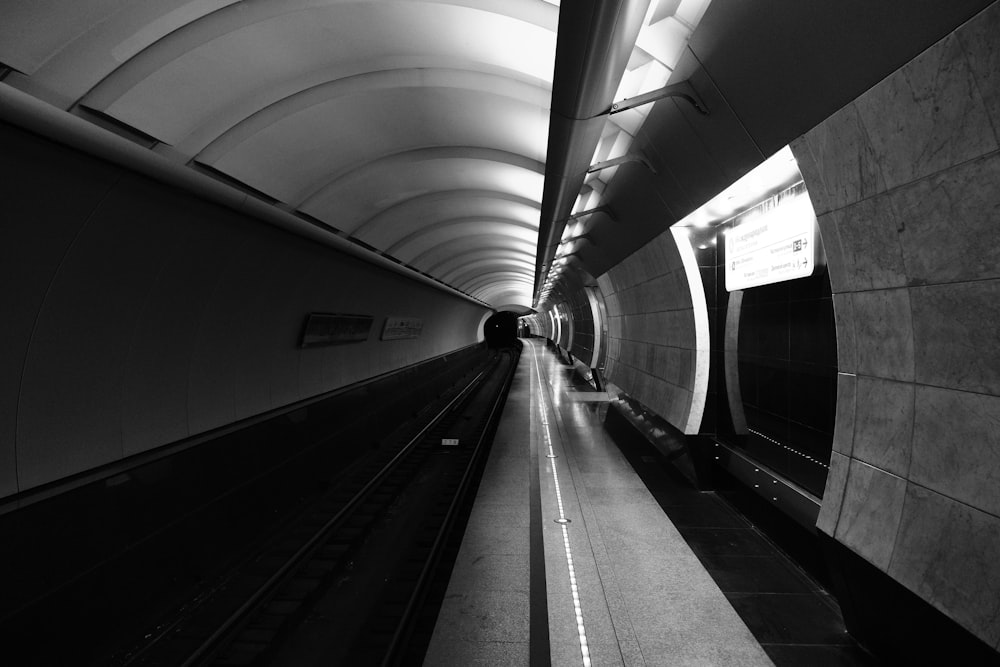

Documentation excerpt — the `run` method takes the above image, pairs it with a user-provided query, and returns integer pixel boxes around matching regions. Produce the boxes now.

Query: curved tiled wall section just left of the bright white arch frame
[598,231,701,431]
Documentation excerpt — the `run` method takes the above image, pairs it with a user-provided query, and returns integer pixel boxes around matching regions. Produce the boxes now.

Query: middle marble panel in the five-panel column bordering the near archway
[838,289,914,380]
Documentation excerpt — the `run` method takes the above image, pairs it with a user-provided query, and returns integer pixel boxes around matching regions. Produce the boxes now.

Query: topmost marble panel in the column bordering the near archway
[792,103,886,215]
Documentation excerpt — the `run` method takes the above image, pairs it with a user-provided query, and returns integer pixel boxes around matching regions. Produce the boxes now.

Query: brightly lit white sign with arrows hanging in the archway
[726,194,816,292]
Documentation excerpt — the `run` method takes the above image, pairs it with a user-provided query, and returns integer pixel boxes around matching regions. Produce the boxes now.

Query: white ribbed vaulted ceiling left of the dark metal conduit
[0,0,559,313]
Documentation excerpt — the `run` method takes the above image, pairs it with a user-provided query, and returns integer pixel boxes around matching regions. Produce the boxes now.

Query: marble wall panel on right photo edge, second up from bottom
[909,386,1000,517]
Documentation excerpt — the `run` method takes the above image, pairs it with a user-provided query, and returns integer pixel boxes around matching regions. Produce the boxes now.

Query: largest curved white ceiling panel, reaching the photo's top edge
[84,0,554,144]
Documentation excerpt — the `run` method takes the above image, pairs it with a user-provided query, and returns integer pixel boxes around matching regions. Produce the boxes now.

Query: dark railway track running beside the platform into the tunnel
[116,350,517,667]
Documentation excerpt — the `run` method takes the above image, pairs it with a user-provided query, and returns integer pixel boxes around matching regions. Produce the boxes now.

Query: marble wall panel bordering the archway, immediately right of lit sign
[837,190,907,292]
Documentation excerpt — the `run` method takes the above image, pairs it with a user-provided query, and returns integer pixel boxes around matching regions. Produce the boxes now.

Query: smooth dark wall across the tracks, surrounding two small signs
[0,125,488,497]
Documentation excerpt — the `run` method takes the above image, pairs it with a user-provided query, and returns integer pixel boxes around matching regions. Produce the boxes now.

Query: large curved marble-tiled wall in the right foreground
[792,3,1000,648]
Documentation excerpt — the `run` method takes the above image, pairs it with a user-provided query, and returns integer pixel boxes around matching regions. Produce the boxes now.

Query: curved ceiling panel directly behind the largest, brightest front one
[198,83,548,203]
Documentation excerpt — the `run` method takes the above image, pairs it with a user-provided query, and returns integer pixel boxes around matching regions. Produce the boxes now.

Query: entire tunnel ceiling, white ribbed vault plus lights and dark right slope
[9,0,976,312]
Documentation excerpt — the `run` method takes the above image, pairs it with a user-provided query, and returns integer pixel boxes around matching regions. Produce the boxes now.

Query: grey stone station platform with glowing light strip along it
[424,338,773,666]
